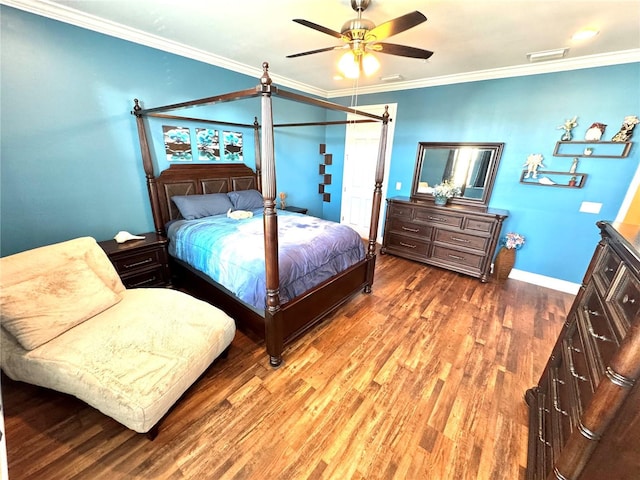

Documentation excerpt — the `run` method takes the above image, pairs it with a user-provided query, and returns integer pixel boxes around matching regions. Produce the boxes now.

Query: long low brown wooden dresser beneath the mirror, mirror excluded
[381,197,509,282]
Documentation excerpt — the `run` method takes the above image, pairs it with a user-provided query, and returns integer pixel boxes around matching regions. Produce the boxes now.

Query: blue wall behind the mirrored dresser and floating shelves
[344,67,640,283]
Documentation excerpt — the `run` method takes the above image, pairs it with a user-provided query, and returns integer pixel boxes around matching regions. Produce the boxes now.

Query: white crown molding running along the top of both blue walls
[0,0,640,98]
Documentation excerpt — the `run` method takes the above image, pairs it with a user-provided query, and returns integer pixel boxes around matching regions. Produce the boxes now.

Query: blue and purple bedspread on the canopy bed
[167,209,365,310]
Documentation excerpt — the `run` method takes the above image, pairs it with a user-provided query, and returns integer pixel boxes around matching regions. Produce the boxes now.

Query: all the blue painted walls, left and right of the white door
[0,6,640,283]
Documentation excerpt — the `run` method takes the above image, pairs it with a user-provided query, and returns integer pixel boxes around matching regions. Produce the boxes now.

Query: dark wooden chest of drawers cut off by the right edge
[525,222,640,480]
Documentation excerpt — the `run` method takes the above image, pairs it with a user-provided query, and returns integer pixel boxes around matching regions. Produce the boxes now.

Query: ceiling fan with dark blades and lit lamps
[287,0,433,78]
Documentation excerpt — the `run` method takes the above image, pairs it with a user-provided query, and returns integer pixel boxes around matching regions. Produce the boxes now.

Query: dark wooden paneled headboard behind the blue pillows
[149,163,259,230]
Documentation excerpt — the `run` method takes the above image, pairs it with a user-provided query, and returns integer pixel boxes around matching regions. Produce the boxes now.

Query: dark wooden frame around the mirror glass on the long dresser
[411,142,504,210]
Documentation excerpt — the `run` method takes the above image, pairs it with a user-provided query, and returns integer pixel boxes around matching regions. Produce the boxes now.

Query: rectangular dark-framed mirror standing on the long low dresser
[411,142,504,209]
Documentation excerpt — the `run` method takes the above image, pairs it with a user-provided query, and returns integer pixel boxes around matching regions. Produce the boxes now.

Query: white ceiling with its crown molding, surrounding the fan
[5,0,640,97]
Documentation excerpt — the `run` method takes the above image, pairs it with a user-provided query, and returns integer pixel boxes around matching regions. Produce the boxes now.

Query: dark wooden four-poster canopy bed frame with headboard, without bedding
[132,63,389,367]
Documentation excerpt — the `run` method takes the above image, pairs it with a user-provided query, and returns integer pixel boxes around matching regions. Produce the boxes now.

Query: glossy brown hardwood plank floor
[2,255,573,480]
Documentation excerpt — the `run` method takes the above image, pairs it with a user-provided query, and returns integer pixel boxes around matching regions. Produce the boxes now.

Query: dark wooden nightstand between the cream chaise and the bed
[98,232,171,288]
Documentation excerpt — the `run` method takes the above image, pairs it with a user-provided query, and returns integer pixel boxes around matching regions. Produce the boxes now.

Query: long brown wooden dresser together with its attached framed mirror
[381,142,509,282]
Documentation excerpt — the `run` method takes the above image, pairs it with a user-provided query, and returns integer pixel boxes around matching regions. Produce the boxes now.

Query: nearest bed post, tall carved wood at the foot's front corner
[258,62,284,367]
